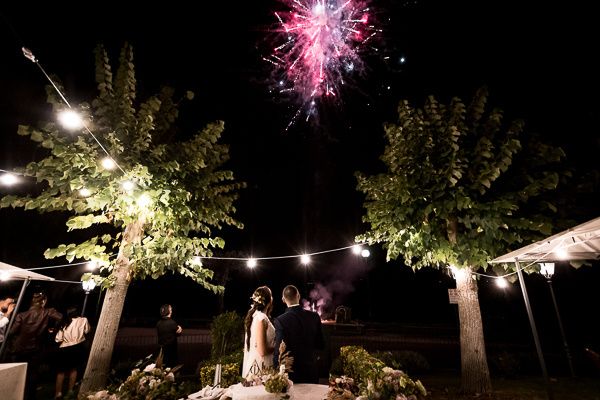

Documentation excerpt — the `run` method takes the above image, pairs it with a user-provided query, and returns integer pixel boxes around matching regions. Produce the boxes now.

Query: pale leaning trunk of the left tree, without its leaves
[79,219,144,395]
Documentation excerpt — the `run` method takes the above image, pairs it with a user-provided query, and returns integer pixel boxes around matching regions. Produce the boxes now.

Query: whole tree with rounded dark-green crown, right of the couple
[357,88,564,393]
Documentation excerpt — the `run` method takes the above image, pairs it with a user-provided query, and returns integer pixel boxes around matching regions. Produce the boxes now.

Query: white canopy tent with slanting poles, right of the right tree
[490,217,600,398]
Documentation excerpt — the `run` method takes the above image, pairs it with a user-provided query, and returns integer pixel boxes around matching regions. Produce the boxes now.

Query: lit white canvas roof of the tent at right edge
[490,217,600,264]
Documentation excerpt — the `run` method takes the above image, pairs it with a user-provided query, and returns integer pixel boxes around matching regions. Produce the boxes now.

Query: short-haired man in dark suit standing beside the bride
[273,285,324,383]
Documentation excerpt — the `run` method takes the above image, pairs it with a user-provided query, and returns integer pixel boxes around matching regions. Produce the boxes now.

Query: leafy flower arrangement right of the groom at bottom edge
[328,346,427,400]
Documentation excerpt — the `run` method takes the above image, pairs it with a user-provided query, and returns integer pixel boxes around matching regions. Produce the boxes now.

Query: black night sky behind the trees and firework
[0,0,600,362]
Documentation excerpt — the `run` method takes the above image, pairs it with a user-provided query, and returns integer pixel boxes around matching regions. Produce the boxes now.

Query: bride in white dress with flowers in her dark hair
[242,286,275,378]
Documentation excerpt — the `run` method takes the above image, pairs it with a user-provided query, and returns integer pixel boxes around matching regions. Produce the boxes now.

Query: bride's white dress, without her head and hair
[242,311,275,378]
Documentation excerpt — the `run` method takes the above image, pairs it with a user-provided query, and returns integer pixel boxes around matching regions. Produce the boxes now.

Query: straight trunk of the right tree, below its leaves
[456,268,492,394]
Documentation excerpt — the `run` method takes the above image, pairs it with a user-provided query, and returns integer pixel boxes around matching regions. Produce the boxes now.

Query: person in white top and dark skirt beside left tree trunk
[54,307,90,399]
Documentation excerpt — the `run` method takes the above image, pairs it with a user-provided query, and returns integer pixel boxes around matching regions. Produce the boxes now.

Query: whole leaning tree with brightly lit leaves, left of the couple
[0,45,243,393]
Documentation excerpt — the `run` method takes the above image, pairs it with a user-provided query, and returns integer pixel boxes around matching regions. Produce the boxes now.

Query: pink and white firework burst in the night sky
[265,0,380,122]
